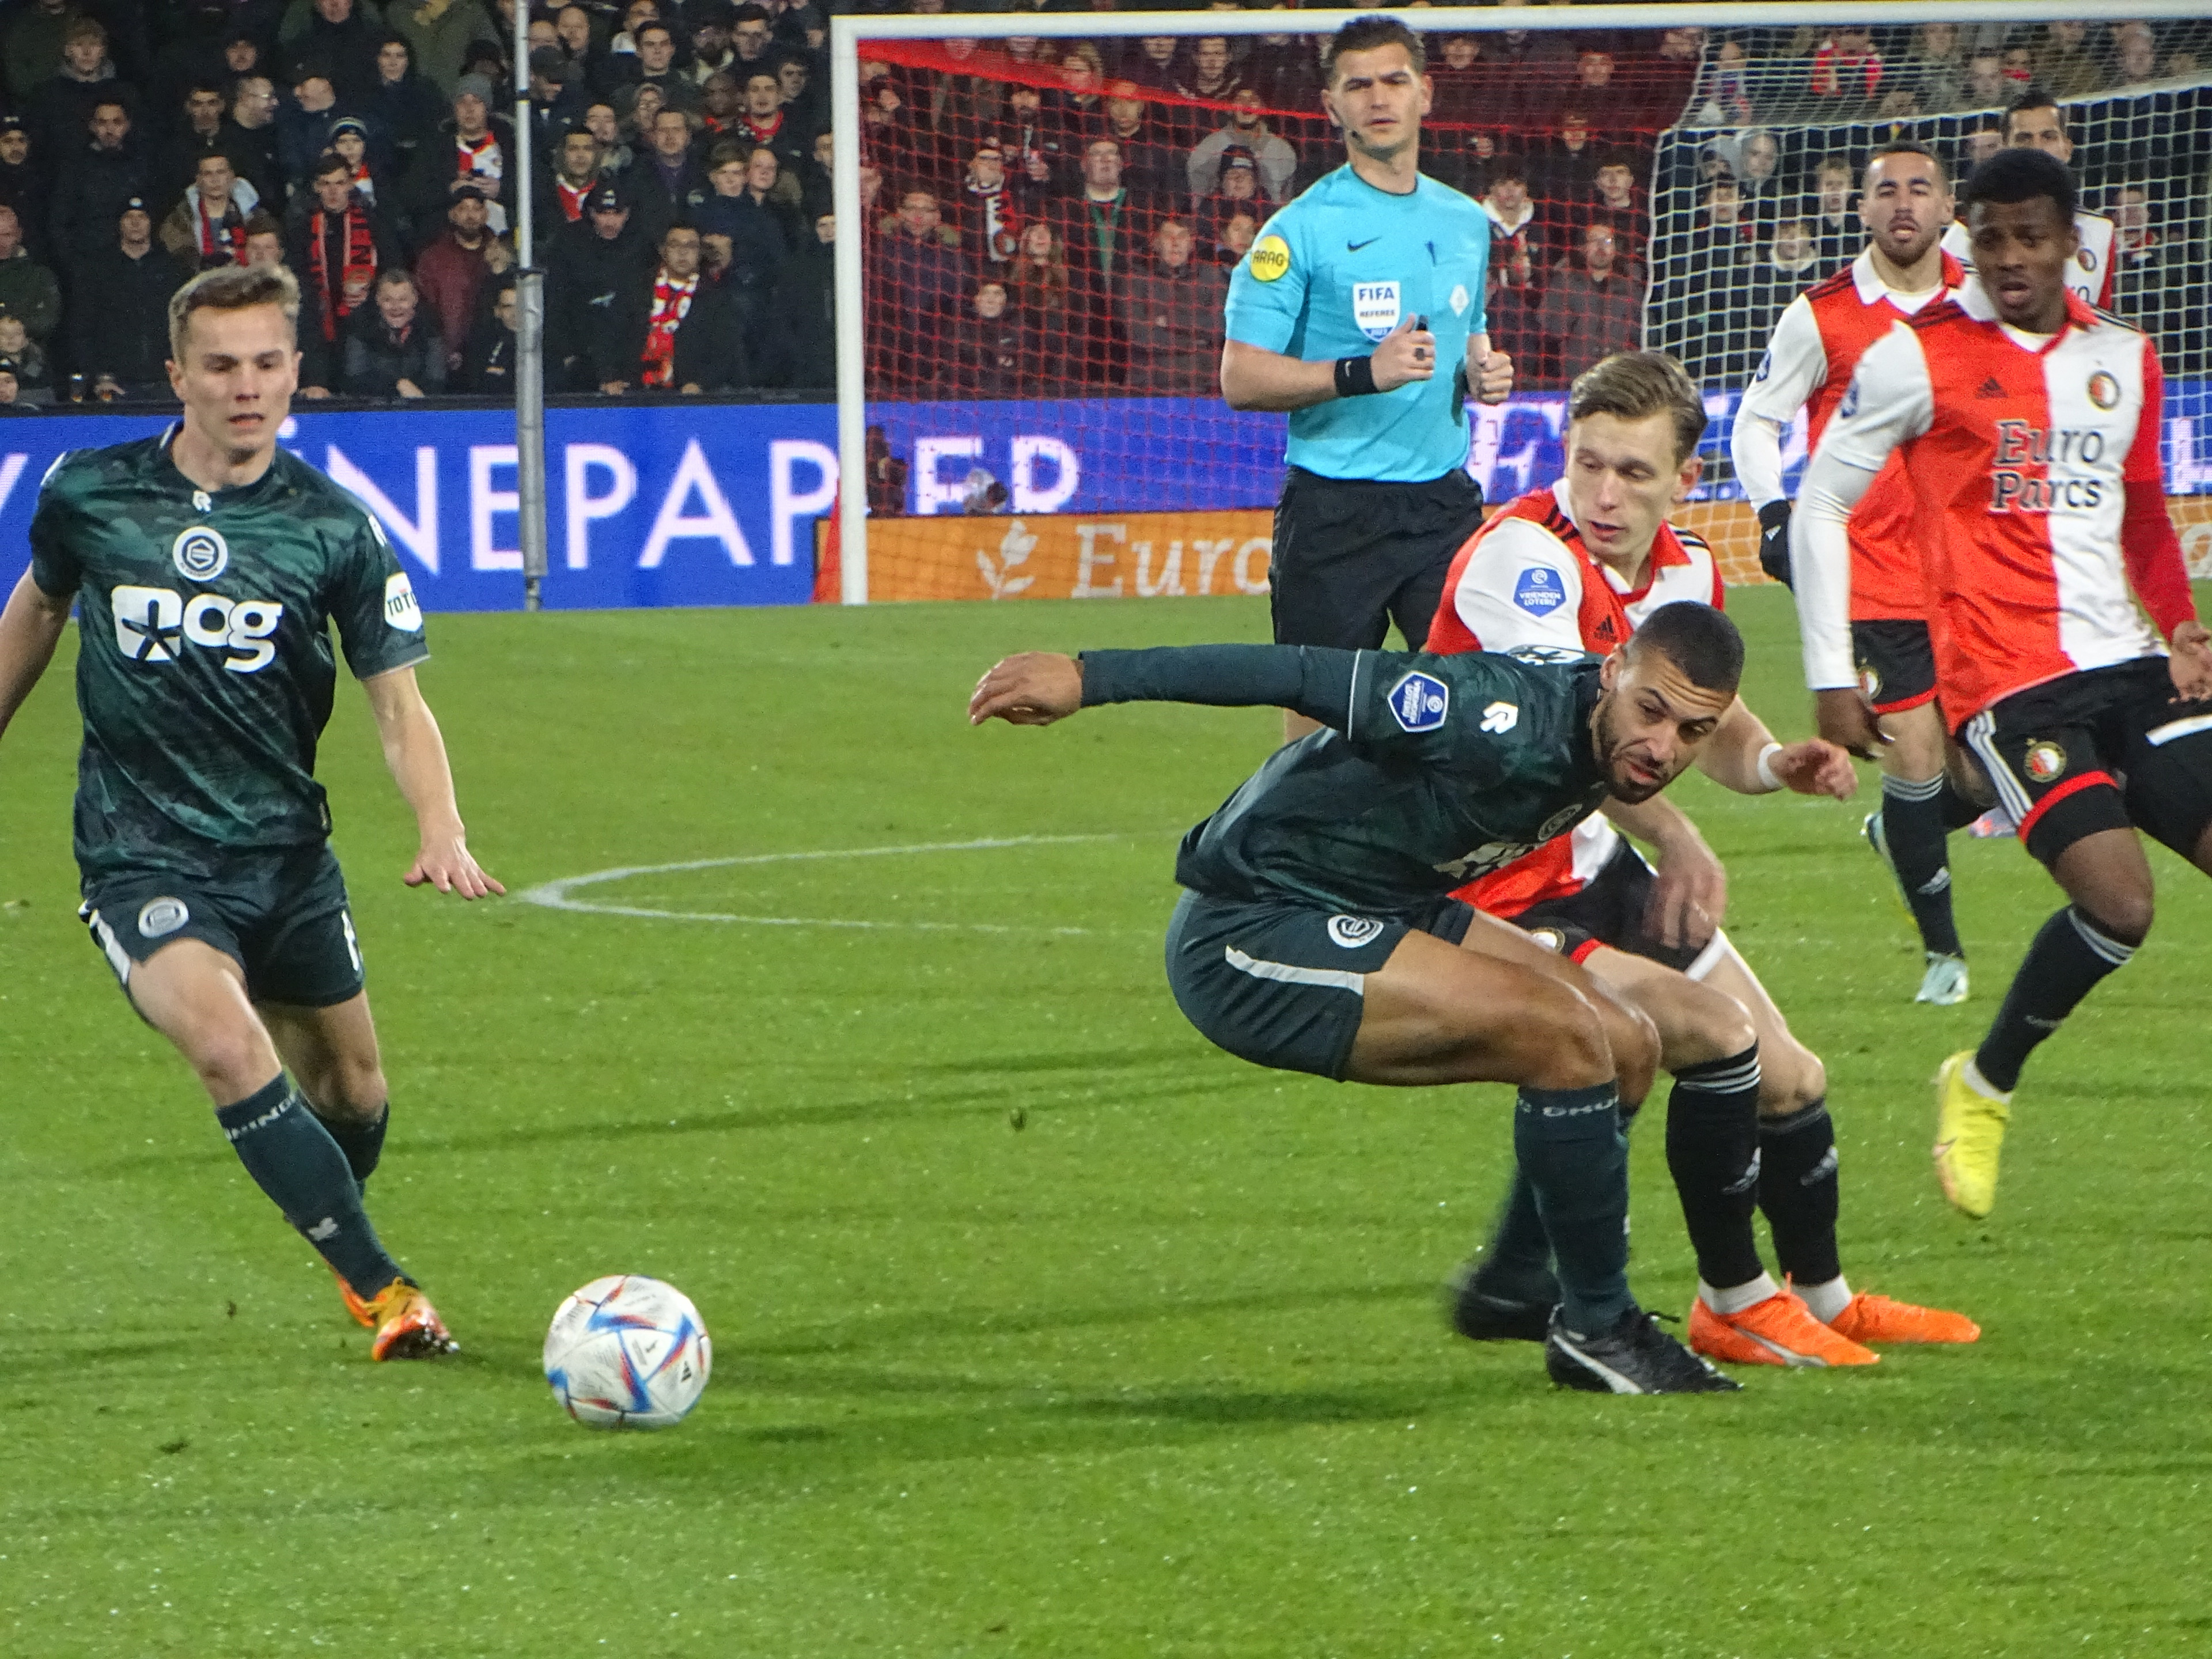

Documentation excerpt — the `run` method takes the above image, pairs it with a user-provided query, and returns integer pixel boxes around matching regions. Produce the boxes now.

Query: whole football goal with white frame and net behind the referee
[823,2,2212,600]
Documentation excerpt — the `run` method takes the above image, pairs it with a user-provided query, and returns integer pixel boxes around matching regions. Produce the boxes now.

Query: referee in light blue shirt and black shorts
[1221,18,1513,737]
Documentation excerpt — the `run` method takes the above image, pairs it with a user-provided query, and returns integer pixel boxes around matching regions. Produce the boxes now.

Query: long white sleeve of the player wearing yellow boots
[1790,323,1936,690]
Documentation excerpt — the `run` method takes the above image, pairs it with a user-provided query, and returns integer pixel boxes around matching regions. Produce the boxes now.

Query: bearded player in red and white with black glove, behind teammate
[1728,144,1978,1004]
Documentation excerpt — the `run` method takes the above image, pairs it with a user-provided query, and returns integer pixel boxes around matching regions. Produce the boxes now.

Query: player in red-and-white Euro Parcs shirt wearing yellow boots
[1791,148,2212,1217]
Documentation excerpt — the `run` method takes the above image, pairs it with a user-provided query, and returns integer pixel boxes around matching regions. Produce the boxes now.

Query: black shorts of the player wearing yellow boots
[1960,657,2212,865]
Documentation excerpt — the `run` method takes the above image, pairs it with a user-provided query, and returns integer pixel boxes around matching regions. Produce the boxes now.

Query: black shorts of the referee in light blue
[1267,467,1482,650]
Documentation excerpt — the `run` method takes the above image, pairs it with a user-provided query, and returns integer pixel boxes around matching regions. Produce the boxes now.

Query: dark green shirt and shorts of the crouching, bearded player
[1084,646,1606,1080]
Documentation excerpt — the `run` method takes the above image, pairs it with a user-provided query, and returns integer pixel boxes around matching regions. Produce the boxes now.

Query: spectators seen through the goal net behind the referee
[861,15,2212,396]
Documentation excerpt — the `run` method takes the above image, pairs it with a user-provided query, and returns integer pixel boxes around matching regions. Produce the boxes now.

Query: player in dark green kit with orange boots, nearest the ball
[0,266,505,1361]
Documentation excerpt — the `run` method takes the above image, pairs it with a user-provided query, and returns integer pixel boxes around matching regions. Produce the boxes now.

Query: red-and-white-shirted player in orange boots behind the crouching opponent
[1429,352,1980,1365]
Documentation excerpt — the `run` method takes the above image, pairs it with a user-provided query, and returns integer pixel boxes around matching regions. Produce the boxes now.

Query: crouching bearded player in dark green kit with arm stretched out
[969,604,1854,1393]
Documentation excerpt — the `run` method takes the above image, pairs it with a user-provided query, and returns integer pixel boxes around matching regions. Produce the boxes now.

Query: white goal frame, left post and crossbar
[830,0,2212,604]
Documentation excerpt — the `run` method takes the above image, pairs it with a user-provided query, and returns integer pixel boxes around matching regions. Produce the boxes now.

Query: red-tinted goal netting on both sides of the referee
[861,31,1699,407]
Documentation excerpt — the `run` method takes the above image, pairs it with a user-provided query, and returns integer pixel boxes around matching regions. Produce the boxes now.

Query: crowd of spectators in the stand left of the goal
[0,0,834,409]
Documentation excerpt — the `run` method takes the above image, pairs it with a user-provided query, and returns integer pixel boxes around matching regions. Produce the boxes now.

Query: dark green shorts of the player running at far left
[77,845,363,1009]
